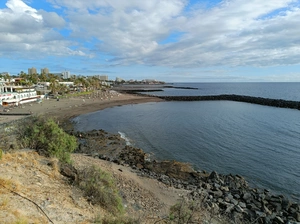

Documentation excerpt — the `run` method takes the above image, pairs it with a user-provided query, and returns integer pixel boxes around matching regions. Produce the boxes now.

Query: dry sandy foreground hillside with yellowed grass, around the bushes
[0,150,185,223]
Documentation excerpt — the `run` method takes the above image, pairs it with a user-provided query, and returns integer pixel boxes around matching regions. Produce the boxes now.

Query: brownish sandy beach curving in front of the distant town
[0,91,162,124]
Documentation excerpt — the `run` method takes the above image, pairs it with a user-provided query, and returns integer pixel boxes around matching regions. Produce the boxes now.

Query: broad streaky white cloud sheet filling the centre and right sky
[48,0,300,67]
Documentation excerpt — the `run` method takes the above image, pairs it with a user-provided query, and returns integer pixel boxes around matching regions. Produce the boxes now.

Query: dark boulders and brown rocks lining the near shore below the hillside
[73,130,300,224]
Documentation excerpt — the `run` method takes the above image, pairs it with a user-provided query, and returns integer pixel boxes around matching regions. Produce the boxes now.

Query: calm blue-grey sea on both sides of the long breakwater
[74,83,300,202]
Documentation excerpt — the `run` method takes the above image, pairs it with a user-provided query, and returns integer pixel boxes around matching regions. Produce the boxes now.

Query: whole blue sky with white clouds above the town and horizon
[0,0,300,82]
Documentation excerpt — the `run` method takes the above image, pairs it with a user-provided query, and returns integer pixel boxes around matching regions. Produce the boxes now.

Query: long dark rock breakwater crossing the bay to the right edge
[155,94,300,110]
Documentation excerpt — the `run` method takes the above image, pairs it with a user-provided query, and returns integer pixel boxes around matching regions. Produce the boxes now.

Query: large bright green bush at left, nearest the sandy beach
[19,117,77,163]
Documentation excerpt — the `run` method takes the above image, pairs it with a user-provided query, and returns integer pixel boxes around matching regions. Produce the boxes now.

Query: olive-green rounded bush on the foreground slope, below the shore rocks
[77,166,124,214]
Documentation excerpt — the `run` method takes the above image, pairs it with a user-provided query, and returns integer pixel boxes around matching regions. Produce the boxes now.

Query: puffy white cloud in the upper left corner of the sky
[0,0,84,58]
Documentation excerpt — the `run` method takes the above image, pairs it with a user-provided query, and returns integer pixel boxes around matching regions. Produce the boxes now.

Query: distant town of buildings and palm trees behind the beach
[0,67,164,106]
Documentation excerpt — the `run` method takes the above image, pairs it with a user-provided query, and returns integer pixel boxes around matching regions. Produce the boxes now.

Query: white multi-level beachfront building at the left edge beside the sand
[0,81,41,106]
